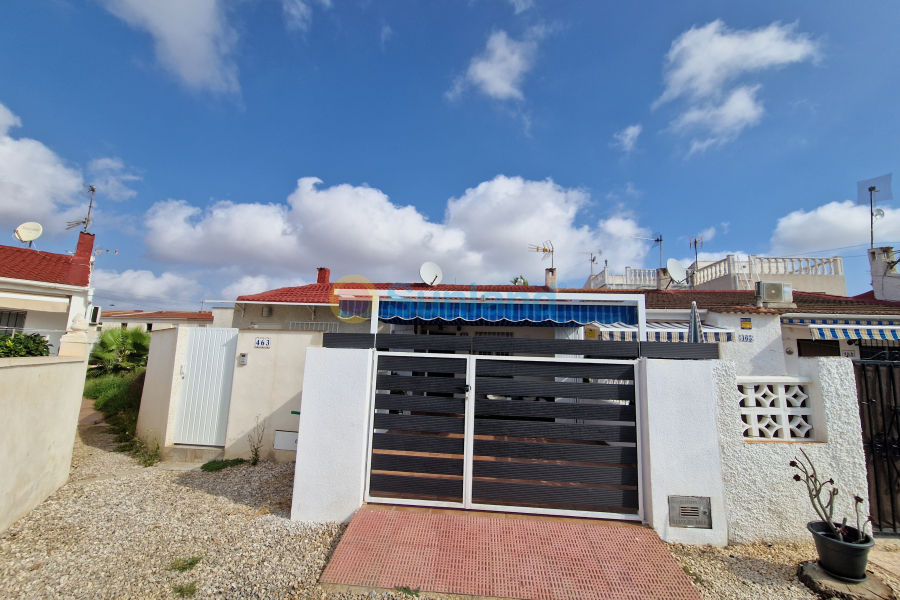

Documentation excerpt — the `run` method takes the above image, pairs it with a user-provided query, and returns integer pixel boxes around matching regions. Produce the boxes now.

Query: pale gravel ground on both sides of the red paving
[7,426,900,600]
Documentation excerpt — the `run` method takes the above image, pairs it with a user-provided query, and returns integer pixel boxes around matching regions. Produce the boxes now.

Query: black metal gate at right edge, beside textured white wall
[854,361,900,533]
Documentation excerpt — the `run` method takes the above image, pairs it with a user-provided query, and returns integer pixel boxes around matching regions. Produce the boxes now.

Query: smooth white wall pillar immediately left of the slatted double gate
[291,348,373,521]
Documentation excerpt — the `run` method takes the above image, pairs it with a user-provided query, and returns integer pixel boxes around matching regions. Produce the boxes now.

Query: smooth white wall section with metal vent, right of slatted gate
[639,360,728,546]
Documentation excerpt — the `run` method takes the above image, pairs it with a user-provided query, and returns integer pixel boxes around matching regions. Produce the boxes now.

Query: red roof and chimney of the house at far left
[0,233,94,287]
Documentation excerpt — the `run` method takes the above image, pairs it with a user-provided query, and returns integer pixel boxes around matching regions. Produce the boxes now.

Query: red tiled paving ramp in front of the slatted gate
[319,507,700,600]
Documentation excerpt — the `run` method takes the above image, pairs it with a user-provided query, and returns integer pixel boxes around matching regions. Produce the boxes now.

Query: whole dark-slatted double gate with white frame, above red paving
[366,352,643,520]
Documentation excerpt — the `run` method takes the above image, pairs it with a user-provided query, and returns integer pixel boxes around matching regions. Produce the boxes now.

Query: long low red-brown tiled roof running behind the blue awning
[237,283,900,315]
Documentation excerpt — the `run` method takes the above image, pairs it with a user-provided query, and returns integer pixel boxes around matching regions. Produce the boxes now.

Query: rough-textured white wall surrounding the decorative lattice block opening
[716,358,868,543]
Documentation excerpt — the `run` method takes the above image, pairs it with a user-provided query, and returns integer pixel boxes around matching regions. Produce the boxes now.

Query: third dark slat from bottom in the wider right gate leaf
[474,436,637,465]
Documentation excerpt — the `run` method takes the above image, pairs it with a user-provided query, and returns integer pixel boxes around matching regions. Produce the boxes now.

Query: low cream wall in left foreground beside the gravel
[0,356,86,532]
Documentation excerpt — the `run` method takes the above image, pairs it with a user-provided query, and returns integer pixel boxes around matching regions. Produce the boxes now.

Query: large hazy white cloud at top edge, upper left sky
[101,0,239,94]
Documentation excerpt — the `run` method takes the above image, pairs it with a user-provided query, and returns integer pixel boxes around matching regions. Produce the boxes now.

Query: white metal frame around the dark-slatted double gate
[365,351,644,521]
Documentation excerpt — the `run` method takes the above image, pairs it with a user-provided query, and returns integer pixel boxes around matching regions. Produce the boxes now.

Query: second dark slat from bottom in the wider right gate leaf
[474,460,637,486]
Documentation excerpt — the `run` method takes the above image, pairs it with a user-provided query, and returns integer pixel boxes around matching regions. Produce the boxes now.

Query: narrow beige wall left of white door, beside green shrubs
[137,327,188,448]
